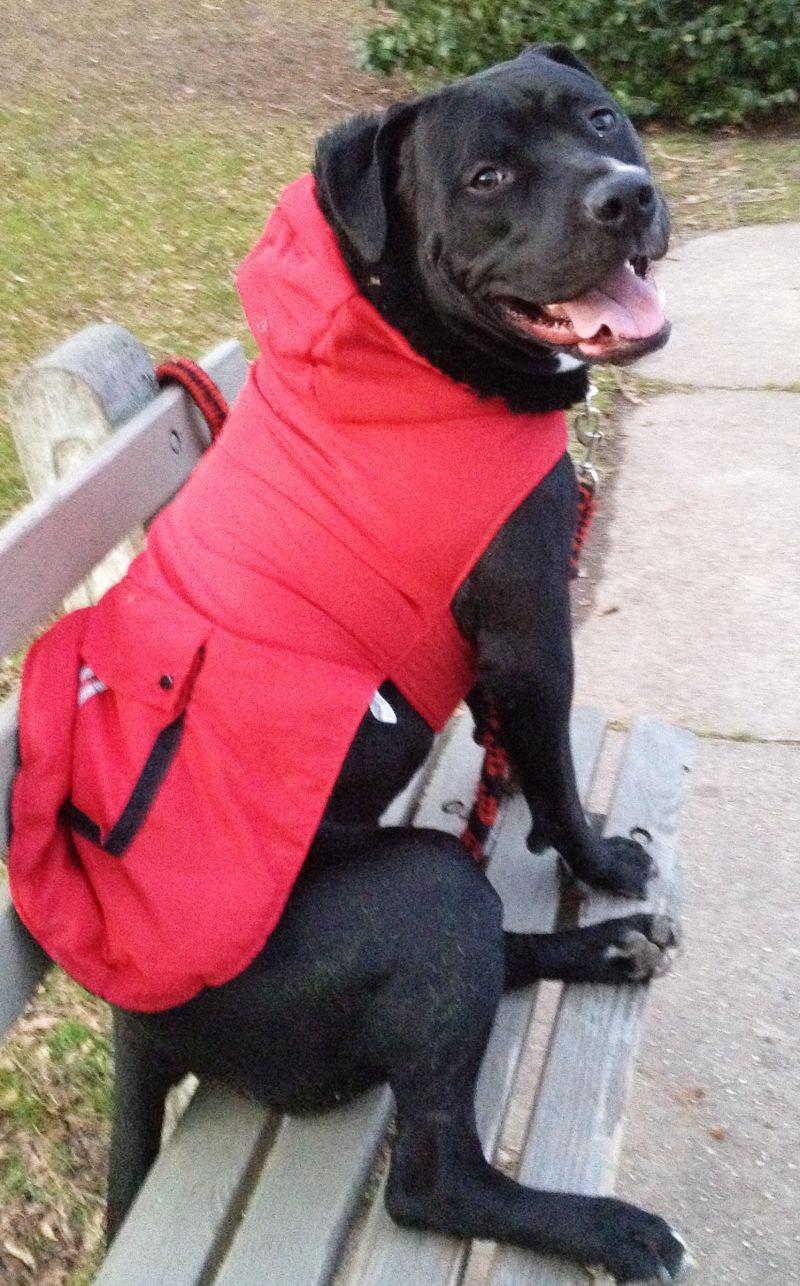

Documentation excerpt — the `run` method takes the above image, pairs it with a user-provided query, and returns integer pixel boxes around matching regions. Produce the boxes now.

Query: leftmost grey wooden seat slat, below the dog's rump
[95,1085,278,1286]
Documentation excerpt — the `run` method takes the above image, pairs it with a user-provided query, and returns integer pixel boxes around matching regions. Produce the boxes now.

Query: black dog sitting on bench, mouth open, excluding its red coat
[109,46,684,1282]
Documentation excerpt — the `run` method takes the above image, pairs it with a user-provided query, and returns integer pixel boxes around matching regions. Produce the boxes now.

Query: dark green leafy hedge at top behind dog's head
[361,0,800,125]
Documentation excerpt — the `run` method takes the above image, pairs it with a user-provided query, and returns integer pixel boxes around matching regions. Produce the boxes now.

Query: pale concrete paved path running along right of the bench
[576,225,800,1286]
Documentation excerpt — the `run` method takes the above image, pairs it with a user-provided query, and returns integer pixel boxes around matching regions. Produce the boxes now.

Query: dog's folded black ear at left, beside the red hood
[314,103,417,264]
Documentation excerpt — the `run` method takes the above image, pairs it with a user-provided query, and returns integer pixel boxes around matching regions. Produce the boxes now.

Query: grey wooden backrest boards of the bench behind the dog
[0,331,247,1037]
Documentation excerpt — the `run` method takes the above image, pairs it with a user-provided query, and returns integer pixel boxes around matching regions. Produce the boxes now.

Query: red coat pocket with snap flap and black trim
[63,581,211,858]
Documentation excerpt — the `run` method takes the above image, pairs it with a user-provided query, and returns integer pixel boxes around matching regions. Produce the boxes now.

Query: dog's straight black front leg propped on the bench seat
[453,457,652,896]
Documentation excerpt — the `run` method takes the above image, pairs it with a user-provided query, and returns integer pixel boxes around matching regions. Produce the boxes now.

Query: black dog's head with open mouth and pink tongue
[315,45,669,369]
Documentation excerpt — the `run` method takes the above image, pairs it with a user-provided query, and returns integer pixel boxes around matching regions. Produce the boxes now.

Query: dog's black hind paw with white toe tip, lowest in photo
[578,1197,692,1286]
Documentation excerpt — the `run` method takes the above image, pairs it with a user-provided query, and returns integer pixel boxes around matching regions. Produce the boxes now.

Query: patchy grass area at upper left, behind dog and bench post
[0,0,401,521]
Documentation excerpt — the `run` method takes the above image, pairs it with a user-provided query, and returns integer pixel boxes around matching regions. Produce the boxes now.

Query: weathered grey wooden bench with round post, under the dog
[0,327,692,1286]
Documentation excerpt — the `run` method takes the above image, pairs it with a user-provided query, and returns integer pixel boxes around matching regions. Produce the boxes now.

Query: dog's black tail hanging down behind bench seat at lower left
[105,1010,186,1244]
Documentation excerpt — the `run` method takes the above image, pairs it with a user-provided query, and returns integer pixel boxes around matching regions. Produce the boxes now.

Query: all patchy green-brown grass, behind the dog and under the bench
[0,0,800,1286]
